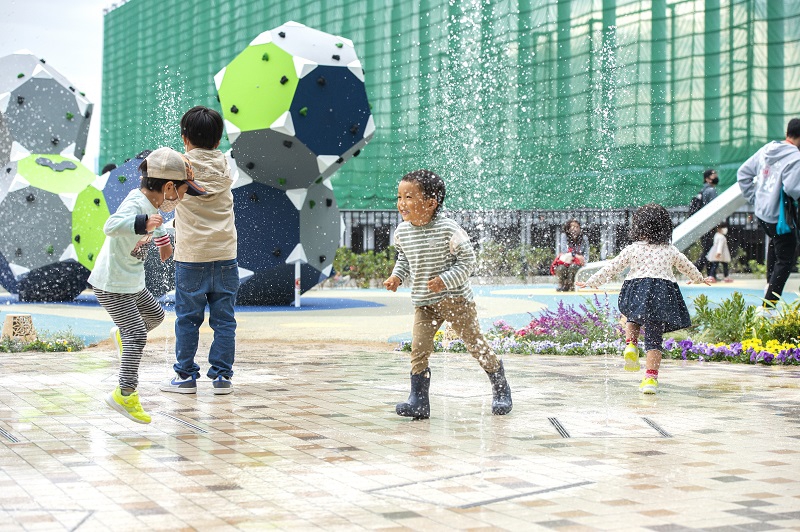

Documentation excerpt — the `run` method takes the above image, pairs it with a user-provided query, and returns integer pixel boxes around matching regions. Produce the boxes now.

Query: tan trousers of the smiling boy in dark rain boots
[411,297,500,375]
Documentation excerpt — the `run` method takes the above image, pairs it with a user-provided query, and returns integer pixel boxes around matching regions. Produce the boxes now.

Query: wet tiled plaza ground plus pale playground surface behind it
[0,279,800,531]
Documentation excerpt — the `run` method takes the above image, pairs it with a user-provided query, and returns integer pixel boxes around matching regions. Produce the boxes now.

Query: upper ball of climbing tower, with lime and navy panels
[214,22,375,190]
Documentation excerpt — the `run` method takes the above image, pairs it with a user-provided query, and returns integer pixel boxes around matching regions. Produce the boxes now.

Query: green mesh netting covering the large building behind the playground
[100,0,800,209]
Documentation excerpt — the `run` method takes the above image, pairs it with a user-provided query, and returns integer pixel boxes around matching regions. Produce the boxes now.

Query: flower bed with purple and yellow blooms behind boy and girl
[397,293,800,365]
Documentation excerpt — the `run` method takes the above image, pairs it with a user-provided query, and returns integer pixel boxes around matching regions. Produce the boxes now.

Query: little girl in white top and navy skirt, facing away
[575,204,708,394]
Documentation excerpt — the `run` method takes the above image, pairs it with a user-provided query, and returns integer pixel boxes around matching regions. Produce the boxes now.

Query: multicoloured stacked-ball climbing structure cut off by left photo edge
[0,50,97,301]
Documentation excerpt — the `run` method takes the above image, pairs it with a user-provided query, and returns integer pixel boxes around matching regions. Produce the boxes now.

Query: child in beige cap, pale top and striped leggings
[89,148,205,423]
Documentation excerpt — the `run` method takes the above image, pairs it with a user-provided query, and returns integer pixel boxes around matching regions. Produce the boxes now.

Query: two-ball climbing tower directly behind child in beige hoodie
[214,22,375,305]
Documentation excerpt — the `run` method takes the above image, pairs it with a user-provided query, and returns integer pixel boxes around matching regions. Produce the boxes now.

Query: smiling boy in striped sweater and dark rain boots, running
[383,170,512,419]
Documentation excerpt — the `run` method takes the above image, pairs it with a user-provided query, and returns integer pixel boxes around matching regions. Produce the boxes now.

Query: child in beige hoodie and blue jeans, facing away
[161,105,239,395]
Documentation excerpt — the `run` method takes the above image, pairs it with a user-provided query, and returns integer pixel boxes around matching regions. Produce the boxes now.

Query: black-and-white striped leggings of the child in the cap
[94,288,164,390]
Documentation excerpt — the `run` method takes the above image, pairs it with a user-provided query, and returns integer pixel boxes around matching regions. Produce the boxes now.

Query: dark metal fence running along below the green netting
[341,206,766,272]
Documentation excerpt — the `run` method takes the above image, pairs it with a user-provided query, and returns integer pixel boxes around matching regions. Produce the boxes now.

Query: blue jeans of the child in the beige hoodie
[174,259,239,379]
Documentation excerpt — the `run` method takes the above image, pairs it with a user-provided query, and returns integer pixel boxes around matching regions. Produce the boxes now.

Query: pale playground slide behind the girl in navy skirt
[577,183,747,281]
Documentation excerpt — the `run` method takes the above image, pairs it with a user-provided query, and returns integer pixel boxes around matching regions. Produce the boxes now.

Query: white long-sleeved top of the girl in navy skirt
[586,242,703,288]
